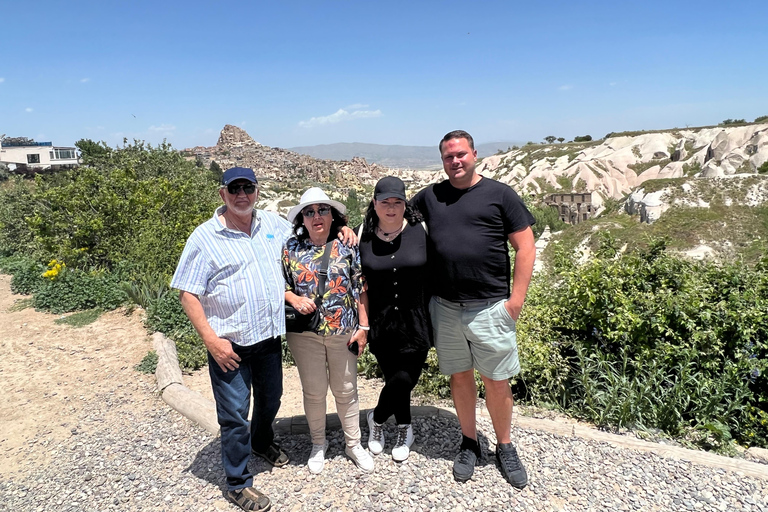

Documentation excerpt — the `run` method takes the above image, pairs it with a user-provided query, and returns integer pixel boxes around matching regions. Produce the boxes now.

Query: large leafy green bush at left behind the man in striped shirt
[0,141,220,276]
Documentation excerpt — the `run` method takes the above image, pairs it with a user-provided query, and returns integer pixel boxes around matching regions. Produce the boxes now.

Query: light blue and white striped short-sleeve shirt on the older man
[171,206,291,346]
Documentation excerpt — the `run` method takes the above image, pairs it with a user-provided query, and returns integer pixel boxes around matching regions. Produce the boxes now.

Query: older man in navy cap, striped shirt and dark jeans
[171,167,291,511]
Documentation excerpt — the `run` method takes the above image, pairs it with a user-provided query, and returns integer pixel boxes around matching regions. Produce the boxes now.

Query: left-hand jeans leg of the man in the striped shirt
[208,350,253,491]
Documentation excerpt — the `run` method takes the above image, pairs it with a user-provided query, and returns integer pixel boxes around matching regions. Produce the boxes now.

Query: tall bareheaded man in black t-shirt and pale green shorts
[413,130,536,488]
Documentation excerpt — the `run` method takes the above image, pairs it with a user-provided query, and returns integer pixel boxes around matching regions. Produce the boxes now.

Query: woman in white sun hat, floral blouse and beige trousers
[283,187,373,473]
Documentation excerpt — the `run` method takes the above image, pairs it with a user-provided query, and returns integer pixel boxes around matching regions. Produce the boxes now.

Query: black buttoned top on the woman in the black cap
[360,223,431,356]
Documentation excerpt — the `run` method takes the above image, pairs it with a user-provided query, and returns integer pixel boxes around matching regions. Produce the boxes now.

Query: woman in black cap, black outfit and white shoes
[360,177,431,461]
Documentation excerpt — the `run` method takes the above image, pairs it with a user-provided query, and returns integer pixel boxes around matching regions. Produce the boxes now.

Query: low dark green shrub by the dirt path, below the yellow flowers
[34,268,127,313]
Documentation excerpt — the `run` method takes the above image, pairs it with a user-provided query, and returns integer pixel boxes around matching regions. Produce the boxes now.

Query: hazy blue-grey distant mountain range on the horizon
[288,142,520,169]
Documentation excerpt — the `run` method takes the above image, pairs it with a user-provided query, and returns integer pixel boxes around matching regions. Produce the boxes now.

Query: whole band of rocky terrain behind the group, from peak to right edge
[185,123,768,230]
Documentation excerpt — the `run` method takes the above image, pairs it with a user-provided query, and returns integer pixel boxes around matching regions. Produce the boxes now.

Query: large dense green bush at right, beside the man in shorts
[517,240,768,448]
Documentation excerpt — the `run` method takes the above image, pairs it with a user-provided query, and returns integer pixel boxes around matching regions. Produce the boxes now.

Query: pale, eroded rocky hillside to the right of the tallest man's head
[479,124,768,204]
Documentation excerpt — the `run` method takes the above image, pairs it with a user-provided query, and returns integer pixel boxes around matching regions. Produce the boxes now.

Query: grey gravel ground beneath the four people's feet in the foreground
[0,377,768,512]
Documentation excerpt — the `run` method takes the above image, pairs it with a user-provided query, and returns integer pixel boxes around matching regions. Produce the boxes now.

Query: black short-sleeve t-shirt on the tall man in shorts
[412,178,535,302]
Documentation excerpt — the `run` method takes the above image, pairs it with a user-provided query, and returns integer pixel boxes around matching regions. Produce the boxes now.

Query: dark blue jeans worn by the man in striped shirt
[208,337,283,490]
